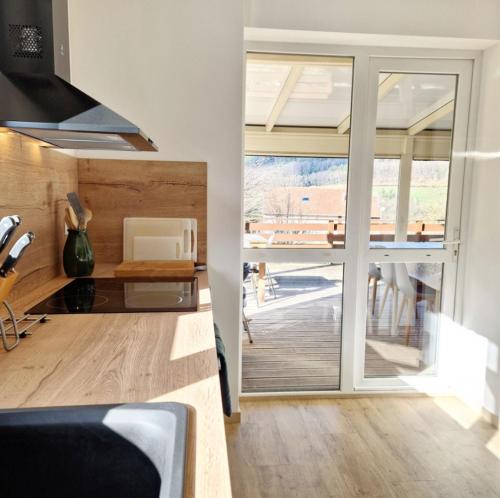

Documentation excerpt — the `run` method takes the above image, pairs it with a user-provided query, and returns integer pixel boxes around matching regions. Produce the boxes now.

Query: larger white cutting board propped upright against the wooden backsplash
[123,218,198,261]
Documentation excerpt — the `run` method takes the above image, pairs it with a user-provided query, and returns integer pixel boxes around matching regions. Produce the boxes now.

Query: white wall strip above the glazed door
[246,0,500,40]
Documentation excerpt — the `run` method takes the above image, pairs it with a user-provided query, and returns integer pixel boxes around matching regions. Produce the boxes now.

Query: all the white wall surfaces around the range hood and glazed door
[65,0,500,414]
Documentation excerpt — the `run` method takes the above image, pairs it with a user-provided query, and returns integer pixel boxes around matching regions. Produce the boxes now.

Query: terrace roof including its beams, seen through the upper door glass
[245,54,456,134]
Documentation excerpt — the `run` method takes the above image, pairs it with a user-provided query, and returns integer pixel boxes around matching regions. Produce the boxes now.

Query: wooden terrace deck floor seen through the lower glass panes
[242,264,434,392]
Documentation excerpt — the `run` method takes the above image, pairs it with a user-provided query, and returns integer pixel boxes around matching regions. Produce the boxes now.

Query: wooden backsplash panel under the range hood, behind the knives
[0,132,78,300]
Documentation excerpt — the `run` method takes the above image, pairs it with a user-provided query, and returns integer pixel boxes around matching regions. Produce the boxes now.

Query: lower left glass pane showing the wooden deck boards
[242,262,344,392]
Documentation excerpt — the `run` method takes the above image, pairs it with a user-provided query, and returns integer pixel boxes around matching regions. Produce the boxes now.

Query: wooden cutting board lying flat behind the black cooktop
[115,260,194,278]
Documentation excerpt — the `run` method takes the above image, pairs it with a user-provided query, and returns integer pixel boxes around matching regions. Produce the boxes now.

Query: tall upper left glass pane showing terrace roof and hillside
[244,54,353,248]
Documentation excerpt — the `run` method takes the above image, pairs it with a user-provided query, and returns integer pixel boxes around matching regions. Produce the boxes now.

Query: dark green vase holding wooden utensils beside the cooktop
[63,230,94,277]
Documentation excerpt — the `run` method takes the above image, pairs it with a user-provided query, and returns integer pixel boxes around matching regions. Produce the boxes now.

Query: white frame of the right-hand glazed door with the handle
[354,57,473,391]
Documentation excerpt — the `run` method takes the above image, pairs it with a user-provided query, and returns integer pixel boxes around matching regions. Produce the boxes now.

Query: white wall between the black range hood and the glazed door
[69,0,243,410]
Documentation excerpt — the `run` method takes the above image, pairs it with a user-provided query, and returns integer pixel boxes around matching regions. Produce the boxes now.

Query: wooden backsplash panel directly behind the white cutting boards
[78,159,207,263]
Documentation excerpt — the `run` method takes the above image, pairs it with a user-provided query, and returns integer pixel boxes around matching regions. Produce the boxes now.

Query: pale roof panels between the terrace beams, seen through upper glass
[245,61,456,130]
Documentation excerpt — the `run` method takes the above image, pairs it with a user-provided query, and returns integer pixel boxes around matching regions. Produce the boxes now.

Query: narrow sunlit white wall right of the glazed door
[458,44,500,422]
